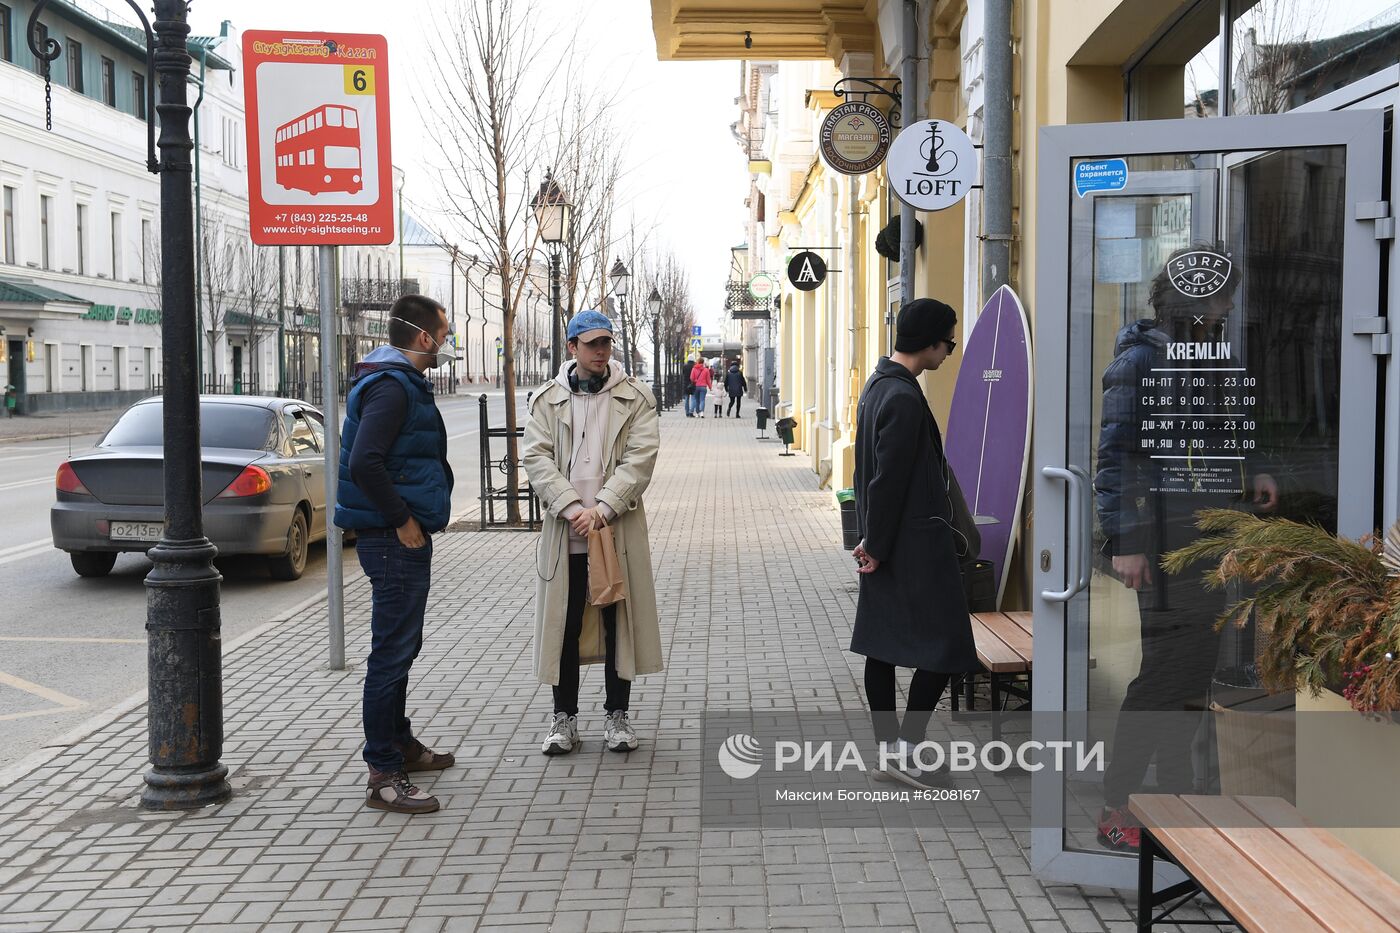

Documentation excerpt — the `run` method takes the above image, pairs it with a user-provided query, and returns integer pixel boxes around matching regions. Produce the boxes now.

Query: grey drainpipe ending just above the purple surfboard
[981,0,1011,301]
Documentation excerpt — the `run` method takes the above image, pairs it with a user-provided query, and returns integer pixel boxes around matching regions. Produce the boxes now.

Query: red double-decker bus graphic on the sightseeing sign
[276,104,364,195]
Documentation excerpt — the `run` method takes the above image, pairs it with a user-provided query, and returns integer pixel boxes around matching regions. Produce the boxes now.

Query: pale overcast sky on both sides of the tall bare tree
[84,0,748,329]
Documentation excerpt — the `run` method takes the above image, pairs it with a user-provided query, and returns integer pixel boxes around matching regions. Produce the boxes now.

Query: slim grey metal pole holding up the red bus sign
[316,247,346,671]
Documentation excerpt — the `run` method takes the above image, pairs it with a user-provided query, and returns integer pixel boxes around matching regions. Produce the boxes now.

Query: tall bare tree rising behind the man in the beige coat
[420,0,561,523]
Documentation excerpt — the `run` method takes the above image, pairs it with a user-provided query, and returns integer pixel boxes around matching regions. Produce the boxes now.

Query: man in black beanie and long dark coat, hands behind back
[851,298,977,787]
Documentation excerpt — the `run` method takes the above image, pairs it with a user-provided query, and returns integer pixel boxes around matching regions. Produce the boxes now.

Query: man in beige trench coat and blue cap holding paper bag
[524,311,662,755]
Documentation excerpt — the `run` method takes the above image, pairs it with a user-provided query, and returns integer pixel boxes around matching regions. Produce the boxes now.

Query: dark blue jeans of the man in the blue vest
[356,535,433,772]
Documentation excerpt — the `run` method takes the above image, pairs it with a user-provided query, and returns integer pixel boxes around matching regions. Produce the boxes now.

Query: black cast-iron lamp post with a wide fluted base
[141,0,232,810]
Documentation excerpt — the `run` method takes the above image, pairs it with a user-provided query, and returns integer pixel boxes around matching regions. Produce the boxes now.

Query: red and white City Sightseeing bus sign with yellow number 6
[244,29,393,247]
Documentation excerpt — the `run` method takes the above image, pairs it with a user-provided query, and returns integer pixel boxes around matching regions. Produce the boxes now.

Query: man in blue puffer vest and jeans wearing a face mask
[336,294,456,813]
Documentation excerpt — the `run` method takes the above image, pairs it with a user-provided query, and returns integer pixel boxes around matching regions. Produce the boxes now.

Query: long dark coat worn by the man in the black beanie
[851,359,977,674]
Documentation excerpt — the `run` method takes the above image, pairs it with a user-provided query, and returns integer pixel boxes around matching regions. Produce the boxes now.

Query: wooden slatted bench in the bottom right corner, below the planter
[1128,794,1400,933]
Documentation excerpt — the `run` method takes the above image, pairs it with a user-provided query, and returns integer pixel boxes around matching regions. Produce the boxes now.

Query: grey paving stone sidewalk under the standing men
[0,412,1204,933]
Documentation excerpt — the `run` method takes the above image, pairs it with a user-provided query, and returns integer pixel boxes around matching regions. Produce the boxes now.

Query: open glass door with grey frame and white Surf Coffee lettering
[1032,111,1383,887]
